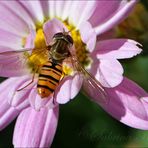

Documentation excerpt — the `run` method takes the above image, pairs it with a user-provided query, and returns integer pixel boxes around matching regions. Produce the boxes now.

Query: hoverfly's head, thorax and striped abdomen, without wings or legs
[37,32,73,98]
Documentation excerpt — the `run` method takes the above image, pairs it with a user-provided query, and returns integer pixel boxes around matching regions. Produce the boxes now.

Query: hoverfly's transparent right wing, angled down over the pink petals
[72,56,109,104]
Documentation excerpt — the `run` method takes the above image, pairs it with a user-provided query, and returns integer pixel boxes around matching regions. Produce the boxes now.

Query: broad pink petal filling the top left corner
[0,2,29,37]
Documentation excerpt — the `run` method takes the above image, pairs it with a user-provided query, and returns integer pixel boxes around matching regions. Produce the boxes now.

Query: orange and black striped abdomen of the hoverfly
[37,61,62,98]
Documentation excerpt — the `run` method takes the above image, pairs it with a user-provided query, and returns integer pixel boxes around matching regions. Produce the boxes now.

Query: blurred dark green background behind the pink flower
[0,0,148,148]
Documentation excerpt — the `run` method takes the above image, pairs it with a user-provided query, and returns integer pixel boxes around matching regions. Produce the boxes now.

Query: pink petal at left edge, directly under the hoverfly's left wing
[0,49,30,77]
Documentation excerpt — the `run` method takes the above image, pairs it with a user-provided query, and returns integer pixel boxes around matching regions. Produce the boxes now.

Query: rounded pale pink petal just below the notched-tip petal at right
[91,58,123,87]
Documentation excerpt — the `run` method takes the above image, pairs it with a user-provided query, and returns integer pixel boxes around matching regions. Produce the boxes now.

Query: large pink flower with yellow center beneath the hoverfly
[0,0,148,147]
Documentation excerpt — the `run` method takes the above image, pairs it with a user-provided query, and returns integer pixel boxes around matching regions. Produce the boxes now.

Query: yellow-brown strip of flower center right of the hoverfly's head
[64,21,92,68]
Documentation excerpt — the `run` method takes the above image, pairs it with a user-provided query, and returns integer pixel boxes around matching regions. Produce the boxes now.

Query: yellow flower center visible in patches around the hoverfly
[25,21,91,75]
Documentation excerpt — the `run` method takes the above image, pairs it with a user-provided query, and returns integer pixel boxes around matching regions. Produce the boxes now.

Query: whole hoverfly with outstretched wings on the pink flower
[0,31,107,102]
